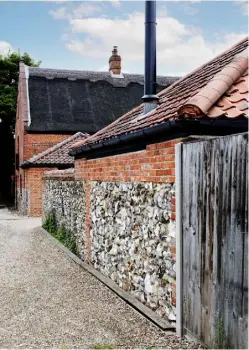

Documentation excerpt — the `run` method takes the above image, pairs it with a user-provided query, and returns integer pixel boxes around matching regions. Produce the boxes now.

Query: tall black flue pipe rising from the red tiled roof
[142,0,158,114]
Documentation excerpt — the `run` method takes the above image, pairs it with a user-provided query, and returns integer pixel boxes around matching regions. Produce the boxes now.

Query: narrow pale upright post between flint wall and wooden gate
[175,143,183,336]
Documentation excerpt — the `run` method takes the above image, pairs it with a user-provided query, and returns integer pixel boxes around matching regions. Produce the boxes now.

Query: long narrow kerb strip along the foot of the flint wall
[40,227,175,331]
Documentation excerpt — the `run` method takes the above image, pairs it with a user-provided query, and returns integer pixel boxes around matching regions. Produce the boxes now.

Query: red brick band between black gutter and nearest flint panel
[75,139,181,183]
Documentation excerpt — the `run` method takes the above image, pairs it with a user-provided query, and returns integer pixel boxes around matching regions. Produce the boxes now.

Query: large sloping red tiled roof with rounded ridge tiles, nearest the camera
[72,37,248,150]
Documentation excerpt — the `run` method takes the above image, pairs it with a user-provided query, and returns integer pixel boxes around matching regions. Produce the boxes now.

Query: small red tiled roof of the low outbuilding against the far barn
[22,132,89,167]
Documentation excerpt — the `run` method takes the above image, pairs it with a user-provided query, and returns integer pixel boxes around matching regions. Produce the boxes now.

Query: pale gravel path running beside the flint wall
[0,209,198,349]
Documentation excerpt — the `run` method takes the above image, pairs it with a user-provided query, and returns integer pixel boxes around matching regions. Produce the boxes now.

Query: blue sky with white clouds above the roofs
[0,0,248,75]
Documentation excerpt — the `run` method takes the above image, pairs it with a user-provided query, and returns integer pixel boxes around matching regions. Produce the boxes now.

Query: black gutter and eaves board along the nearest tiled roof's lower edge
[69,119,248,158]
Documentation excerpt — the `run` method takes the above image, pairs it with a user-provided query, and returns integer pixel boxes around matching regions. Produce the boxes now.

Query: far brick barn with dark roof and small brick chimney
[15,46,177,215]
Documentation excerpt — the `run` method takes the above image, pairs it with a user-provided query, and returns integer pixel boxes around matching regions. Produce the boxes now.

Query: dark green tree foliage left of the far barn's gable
[0,52,41,132]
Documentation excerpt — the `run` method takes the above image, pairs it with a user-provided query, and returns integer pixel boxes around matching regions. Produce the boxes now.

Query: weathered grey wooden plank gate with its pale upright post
[176,134,248,349]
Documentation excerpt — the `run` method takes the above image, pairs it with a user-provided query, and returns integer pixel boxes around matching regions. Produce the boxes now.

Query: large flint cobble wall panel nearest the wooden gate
[91,181,176,321]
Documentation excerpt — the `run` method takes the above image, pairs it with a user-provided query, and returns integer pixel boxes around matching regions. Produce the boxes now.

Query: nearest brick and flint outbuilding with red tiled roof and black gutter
[64,38,248,321]
